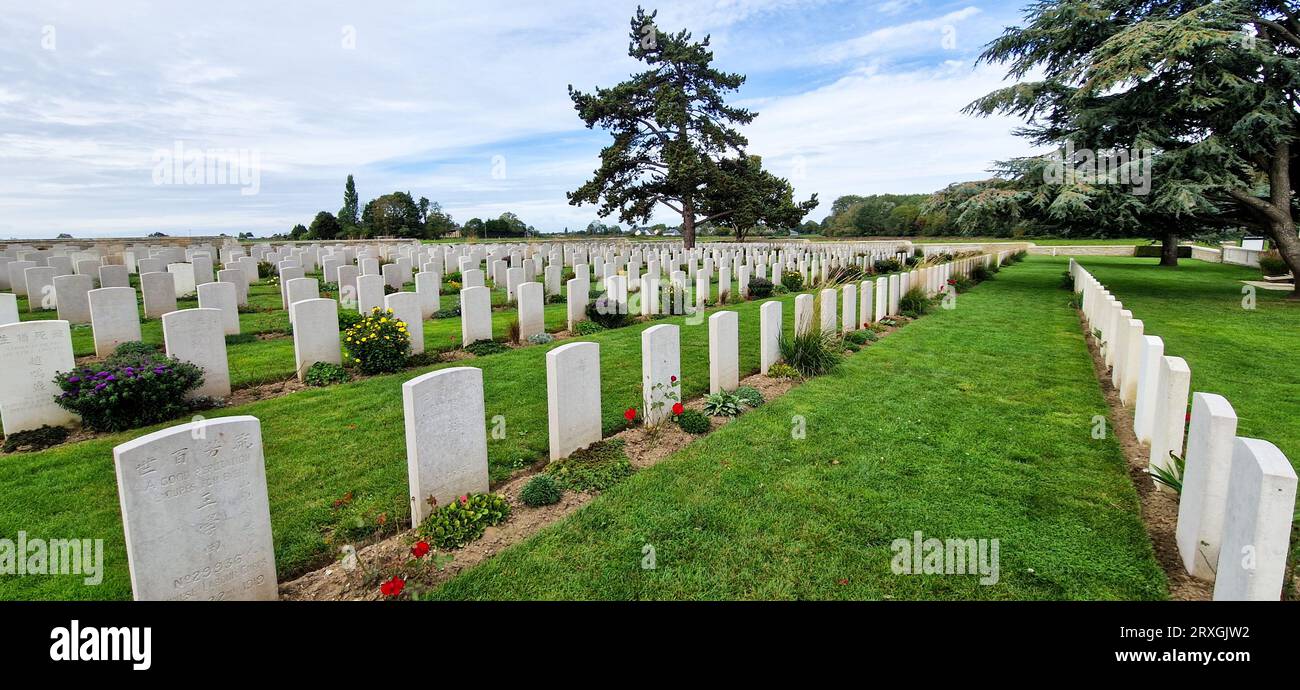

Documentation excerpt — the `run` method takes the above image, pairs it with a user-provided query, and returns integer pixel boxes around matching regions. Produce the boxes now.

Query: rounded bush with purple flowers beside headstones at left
[55,343,203,431]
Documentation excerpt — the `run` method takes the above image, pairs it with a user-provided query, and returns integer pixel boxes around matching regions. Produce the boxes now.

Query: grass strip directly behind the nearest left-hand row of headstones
[0,280,794,600]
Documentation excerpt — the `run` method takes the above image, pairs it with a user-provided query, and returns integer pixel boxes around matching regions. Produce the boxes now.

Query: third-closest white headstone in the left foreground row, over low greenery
[546,343,601,461]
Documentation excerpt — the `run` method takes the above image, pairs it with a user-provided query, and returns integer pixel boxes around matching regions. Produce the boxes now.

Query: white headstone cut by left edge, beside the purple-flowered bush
[0,321,77,435]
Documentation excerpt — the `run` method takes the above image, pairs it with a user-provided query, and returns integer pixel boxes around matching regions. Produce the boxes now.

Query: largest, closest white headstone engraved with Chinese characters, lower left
[113,417,278,602]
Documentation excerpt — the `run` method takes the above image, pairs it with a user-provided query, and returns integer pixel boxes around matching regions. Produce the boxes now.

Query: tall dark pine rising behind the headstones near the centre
[568,8,816,248]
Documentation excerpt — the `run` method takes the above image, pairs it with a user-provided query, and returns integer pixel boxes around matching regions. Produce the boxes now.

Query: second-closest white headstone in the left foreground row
[402,369,488,526]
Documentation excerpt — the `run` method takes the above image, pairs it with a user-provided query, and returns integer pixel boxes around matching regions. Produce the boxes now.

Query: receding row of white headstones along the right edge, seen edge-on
[1070,259,1296,602]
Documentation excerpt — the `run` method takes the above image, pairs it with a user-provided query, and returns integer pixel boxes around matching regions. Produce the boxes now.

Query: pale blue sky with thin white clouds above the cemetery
[0,0,1028,238]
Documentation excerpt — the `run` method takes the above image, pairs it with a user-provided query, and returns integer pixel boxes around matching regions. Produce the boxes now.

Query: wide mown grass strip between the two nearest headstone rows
[433,260,1166,599]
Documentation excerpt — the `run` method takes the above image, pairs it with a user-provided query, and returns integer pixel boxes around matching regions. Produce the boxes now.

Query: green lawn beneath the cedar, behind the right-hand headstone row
[1056,256,1300,466]
